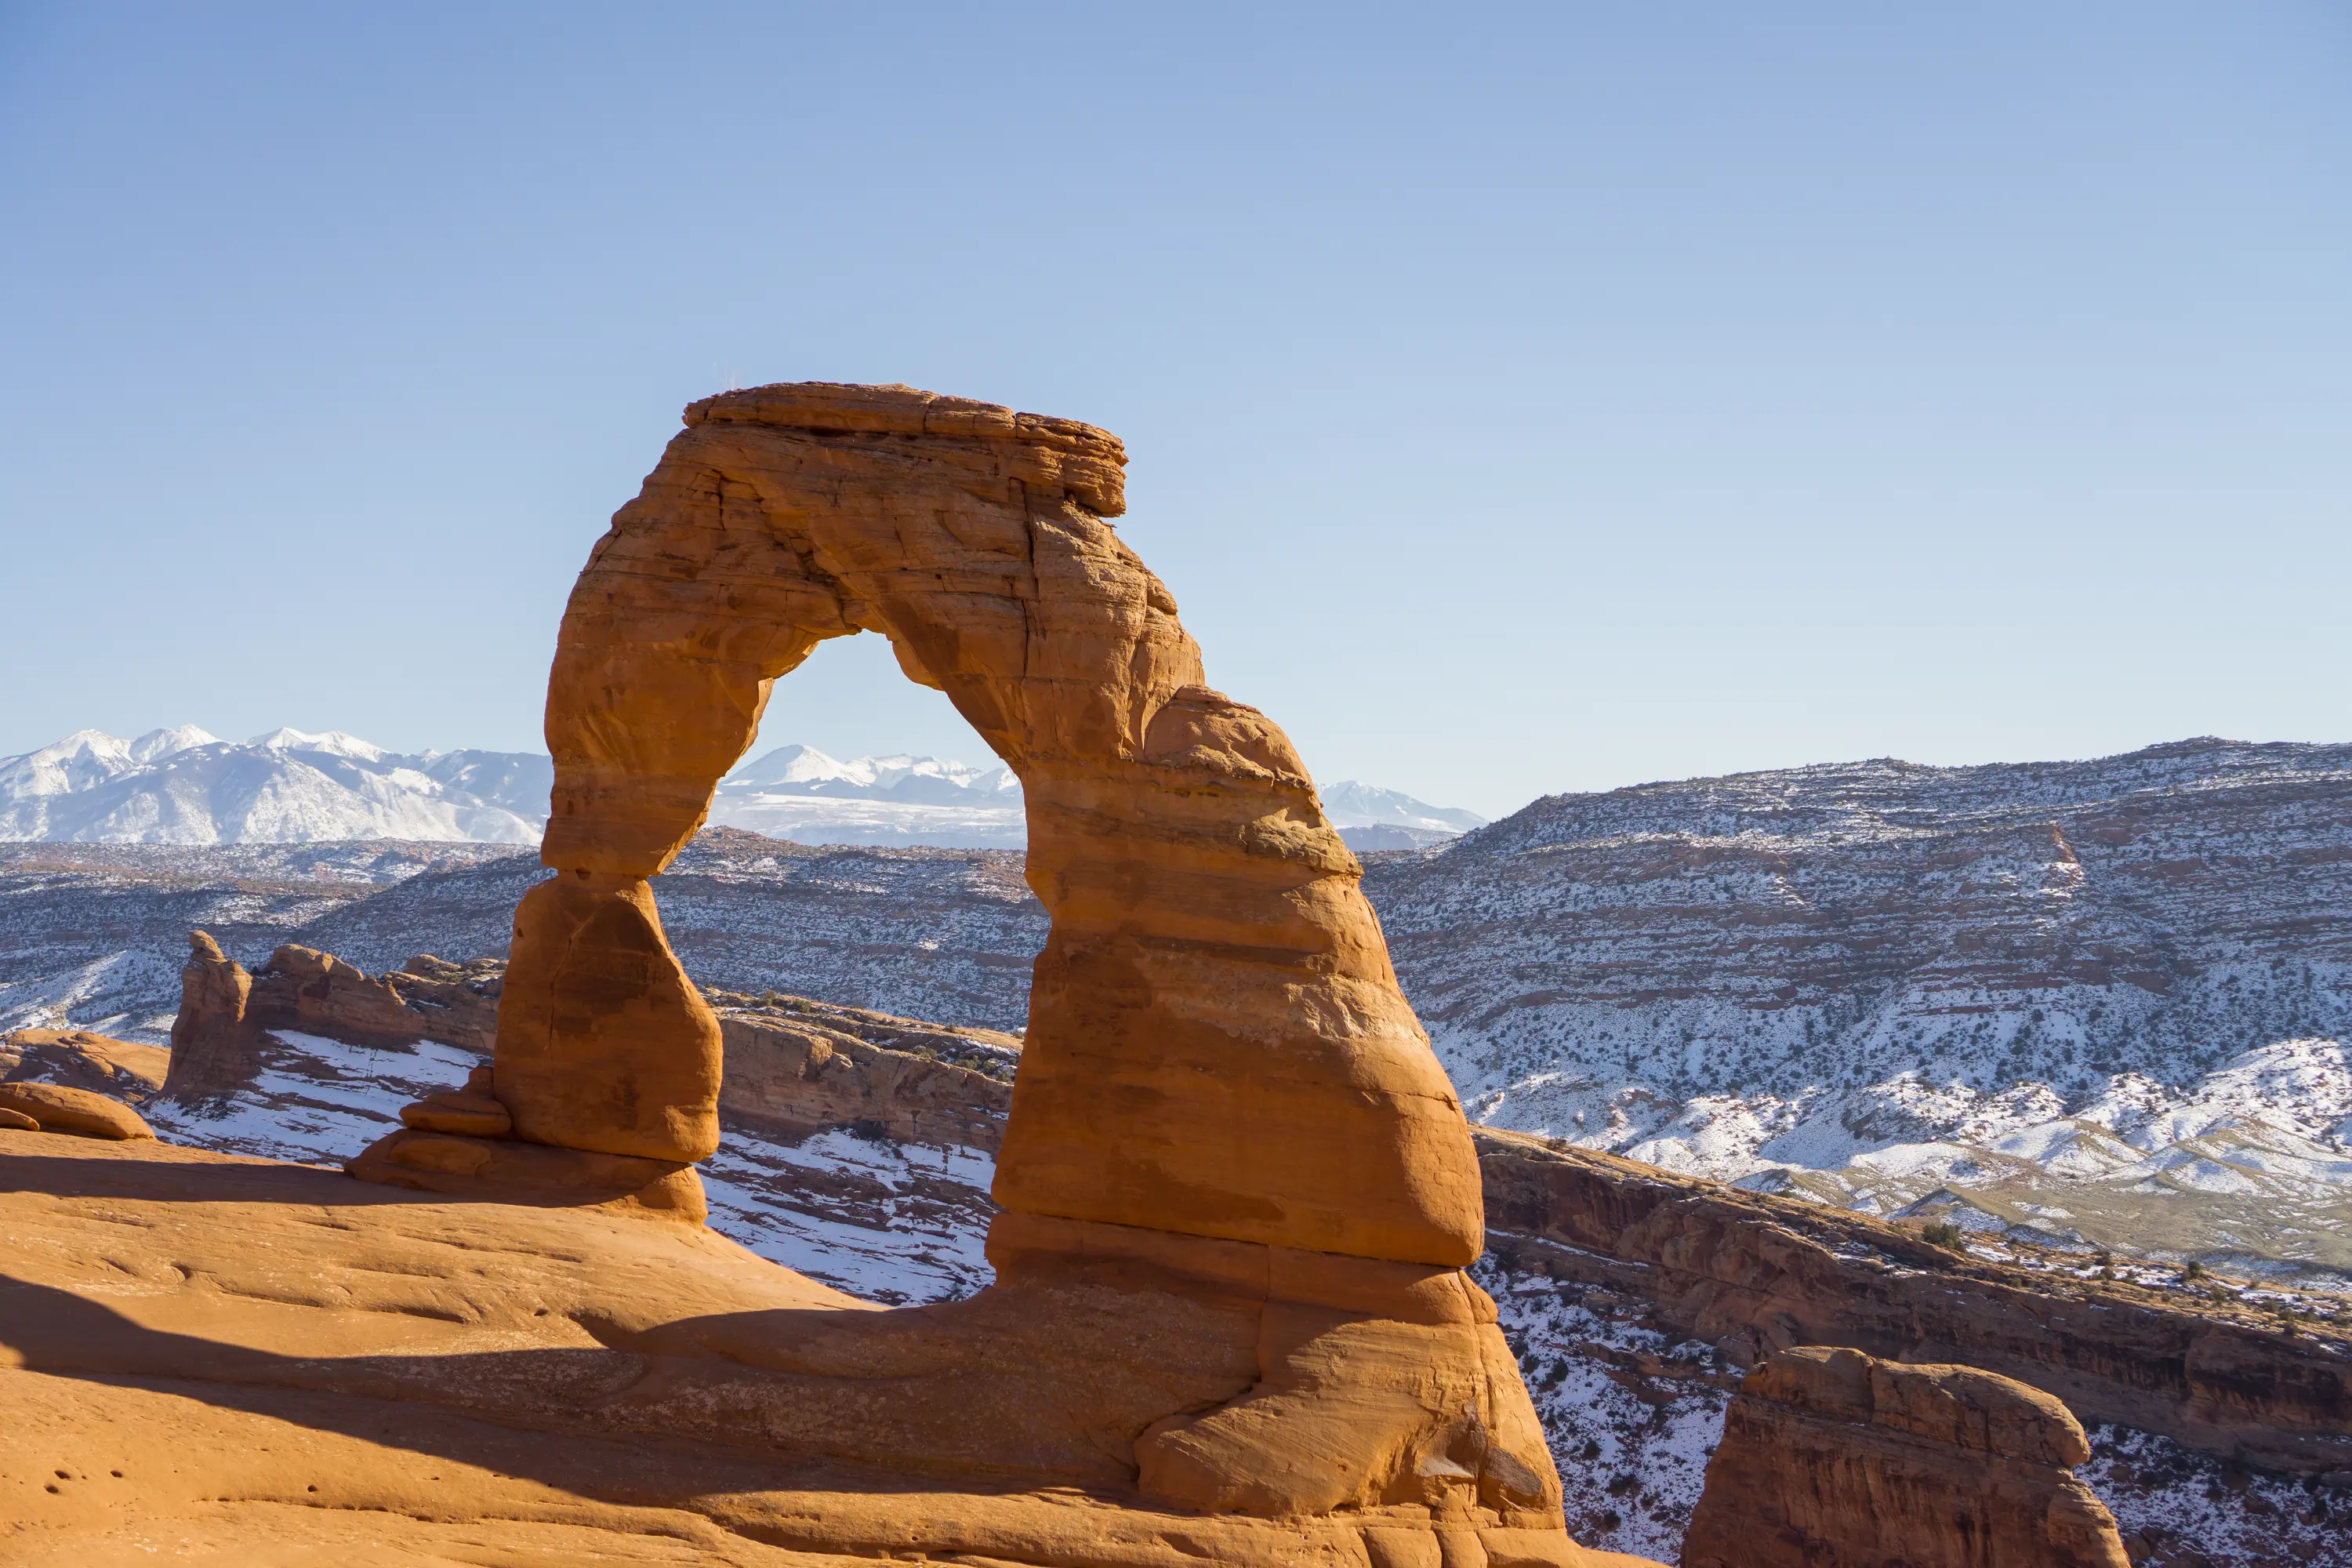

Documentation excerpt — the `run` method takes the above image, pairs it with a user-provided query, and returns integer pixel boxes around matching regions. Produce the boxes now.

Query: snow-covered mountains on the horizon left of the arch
[0,724,555,844]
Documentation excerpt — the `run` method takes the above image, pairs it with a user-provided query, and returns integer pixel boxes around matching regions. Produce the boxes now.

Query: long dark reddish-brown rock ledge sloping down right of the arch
[1479,1131,2352,1474]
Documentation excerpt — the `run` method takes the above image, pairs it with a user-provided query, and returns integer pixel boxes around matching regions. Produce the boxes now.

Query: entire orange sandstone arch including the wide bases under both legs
[350,386,1576,1563]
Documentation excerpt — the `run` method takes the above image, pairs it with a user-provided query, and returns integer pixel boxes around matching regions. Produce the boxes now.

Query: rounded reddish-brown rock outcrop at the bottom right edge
[1682,1349,2129,1568]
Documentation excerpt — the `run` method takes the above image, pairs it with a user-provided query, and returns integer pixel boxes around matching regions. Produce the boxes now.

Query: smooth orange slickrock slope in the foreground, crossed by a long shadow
[0,1133,1637,1568]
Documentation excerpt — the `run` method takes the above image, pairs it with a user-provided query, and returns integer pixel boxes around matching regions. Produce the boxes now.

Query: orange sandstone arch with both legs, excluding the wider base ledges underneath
[496,383,1479,1265]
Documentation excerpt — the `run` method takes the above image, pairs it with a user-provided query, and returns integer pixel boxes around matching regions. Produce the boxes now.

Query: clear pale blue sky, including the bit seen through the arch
[0,2,2352,813]
